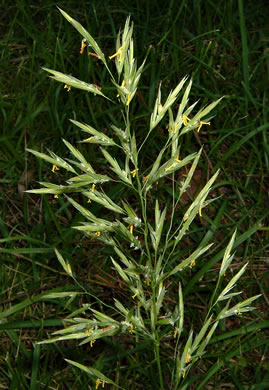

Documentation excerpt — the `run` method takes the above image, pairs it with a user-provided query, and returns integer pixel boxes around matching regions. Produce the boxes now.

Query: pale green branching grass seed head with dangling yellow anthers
[28,10,258,389]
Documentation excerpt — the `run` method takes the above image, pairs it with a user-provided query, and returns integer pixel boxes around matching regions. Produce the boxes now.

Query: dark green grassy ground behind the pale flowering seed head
[0,0,269,390]
